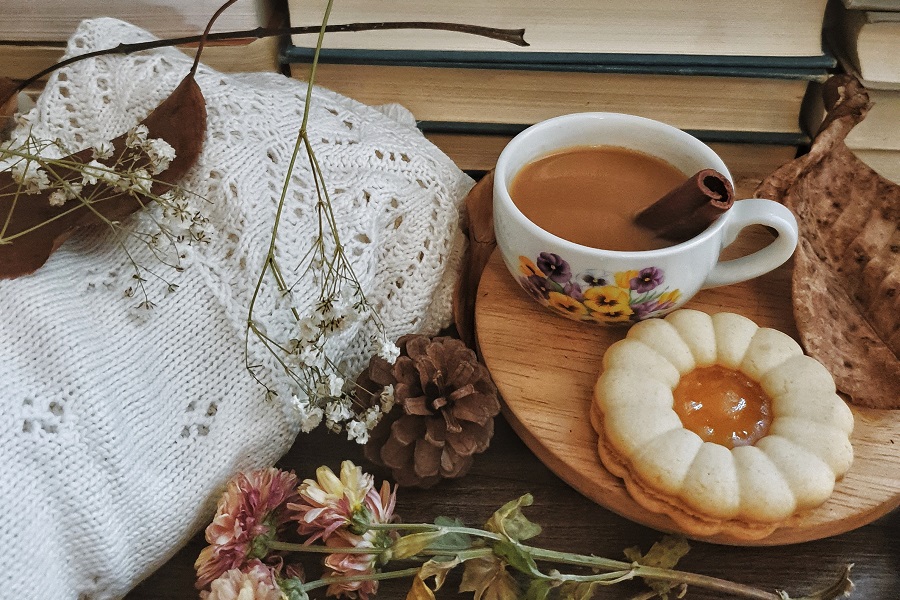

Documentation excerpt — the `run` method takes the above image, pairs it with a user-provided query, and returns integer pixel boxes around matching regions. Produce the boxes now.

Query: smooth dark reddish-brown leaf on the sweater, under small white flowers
[0,72,206,279]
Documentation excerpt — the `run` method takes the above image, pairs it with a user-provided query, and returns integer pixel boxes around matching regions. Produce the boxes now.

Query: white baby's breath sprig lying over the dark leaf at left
[0,123,208,309]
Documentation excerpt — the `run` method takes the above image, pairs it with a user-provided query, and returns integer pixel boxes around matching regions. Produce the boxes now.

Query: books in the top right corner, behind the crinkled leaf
[820,0,900,182]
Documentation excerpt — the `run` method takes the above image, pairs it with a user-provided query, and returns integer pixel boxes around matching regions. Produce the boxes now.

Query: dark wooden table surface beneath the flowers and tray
[127,417,900,600]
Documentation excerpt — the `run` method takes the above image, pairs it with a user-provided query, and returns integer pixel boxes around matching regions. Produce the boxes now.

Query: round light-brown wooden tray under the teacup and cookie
[475,240,900,546]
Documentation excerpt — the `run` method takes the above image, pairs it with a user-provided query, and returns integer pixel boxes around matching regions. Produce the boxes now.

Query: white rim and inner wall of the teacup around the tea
[494,112,734,260]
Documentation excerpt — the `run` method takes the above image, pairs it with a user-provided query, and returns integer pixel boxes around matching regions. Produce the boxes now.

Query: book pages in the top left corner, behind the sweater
[0,0,279,86]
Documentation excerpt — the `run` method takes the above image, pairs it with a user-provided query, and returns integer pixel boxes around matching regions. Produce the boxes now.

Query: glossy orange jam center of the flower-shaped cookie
[673,365,772,448]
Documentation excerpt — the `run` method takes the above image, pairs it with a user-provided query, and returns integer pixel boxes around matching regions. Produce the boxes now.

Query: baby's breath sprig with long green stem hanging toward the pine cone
[246,2,400,444]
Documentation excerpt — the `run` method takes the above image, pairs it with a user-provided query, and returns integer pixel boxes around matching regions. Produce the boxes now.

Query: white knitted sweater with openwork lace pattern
[0,19,472,600]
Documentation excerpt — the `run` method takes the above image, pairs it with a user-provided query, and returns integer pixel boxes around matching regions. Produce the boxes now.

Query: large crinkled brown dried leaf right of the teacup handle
[756,75,900,409]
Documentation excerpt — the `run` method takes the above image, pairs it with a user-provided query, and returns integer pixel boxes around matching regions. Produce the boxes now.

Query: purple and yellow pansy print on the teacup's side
[519,252,681,323]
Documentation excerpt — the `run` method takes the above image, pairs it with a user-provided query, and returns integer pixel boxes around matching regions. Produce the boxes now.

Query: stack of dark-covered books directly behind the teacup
[283,0,835,174]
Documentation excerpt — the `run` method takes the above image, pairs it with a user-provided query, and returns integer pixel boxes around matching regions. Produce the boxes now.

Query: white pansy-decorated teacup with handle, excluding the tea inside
[494,113,797,324]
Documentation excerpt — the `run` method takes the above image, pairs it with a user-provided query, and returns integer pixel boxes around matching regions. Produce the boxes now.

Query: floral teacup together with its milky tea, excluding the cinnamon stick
[494,113,797,325]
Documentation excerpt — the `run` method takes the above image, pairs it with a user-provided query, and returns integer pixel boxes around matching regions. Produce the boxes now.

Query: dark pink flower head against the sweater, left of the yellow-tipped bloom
[194,468,297,589]
